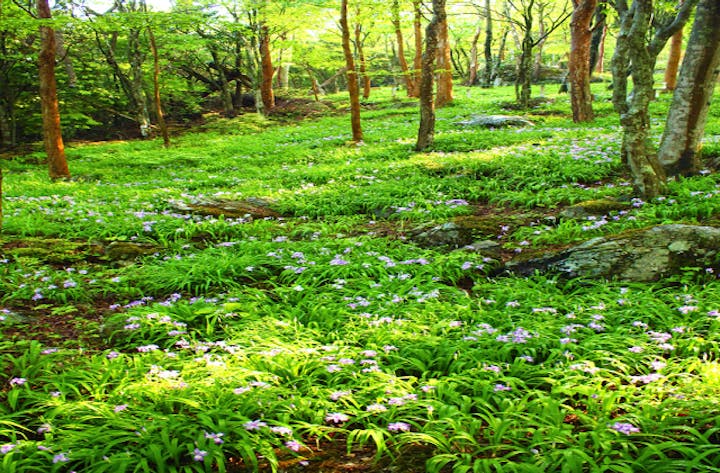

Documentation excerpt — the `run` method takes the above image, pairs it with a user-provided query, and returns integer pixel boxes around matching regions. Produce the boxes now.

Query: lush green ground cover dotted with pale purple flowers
[0,88,720,473]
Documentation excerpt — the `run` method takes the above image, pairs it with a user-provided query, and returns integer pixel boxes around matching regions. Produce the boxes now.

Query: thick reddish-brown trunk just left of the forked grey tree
[568,0,597,123]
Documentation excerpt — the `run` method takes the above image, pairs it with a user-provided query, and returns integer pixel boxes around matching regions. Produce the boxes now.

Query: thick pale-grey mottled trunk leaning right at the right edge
[658,0,720,176]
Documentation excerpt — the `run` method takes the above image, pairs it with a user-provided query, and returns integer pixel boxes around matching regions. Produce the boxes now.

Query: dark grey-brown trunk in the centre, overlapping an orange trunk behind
[415,0,447,151]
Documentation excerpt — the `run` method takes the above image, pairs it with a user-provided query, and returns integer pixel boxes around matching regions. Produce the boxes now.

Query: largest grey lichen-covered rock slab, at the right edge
[504,224,720,282]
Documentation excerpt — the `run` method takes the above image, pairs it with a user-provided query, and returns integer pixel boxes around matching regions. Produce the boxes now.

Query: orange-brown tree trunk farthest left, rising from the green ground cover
[37,0,70,179]
